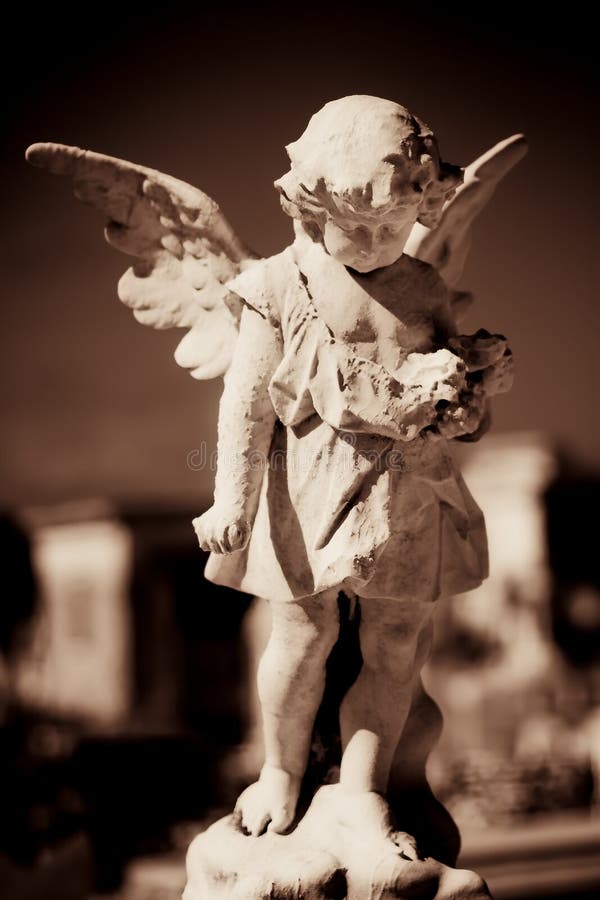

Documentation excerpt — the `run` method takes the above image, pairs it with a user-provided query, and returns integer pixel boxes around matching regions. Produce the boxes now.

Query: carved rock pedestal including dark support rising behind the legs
[184,597,490,900]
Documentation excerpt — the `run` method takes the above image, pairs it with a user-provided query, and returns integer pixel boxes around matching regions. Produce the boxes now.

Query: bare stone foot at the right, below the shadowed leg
[319,784,421,860]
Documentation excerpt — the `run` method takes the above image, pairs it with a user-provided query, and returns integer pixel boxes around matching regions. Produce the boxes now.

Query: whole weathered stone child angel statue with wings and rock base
[27,96,526,900]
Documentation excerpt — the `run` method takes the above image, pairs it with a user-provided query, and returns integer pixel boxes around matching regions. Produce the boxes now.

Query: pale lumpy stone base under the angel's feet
[183,785,490,900]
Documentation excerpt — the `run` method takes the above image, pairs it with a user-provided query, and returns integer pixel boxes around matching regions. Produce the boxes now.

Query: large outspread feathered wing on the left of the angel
[26,143,256,379]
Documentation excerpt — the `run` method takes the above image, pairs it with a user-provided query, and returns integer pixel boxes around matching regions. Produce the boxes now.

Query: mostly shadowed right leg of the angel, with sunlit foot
[340,598,433,858]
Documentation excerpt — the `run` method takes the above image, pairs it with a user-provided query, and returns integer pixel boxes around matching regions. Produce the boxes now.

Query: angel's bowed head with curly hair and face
[275,95,462,272]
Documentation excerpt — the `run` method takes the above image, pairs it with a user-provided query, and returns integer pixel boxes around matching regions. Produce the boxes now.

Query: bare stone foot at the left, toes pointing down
[234,763,302,837]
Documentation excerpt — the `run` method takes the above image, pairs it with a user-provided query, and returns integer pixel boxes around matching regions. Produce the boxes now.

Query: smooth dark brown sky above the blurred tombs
[2,3,600,502]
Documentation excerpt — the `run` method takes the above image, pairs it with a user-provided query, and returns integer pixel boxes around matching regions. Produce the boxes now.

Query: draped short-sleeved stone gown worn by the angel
[205,242,487,602]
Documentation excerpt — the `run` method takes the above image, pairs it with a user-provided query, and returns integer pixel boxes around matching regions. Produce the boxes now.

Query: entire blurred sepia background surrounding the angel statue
[0,2,600,900]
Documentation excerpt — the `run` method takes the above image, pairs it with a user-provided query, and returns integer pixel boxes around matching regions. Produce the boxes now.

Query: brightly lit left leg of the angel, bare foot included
[236,589,339,836]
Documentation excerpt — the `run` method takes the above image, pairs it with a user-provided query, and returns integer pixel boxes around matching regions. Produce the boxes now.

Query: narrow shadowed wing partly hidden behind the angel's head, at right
[404,134,527,288]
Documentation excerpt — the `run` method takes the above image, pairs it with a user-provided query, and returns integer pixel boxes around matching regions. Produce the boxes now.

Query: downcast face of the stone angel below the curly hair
[323,209,417,272]
